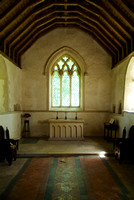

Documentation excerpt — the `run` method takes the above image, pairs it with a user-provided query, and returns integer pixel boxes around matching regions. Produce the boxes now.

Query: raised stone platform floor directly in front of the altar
[18,137,113,156]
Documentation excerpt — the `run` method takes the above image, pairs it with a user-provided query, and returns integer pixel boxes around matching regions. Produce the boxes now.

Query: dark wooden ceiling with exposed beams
[0,0,134,67]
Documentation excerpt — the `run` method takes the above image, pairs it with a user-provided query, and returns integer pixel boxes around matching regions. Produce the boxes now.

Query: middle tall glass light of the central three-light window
[62,72,70,106]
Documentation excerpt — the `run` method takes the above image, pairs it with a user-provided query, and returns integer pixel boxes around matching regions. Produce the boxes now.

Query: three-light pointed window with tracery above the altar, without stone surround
[51,55,81,108]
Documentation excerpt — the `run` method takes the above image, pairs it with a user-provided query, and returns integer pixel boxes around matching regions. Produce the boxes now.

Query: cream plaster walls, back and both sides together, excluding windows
[0,29,134,138]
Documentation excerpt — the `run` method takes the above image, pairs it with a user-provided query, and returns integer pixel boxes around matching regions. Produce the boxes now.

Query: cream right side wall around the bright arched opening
[110,55,134,137]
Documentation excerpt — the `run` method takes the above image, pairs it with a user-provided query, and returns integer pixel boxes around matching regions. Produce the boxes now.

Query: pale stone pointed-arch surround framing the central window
[44,47,87,111]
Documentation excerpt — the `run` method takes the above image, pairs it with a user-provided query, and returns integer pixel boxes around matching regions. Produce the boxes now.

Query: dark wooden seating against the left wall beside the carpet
[0,126,17,165]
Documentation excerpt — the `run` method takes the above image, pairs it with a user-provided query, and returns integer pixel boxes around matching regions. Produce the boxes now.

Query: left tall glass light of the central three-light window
[52,72,60,106]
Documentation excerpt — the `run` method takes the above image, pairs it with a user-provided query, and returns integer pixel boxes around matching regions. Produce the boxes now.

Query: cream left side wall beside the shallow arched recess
[0,54,22,138]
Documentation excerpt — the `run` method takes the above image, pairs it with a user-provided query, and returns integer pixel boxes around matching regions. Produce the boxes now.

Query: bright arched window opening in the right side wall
[124,56,134,112]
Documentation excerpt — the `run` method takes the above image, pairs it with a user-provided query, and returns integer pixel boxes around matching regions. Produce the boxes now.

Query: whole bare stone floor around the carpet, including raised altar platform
[0,137,134,200]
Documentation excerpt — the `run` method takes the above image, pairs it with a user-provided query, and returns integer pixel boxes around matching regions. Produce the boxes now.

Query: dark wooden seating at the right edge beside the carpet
[114,126,134,163]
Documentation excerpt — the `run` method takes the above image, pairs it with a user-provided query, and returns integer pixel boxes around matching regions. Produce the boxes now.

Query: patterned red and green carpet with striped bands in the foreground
[0,156,128,200]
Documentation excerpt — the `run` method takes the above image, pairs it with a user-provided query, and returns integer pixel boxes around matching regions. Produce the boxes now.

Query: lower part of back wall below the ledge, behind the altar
[22,111,109,137]
